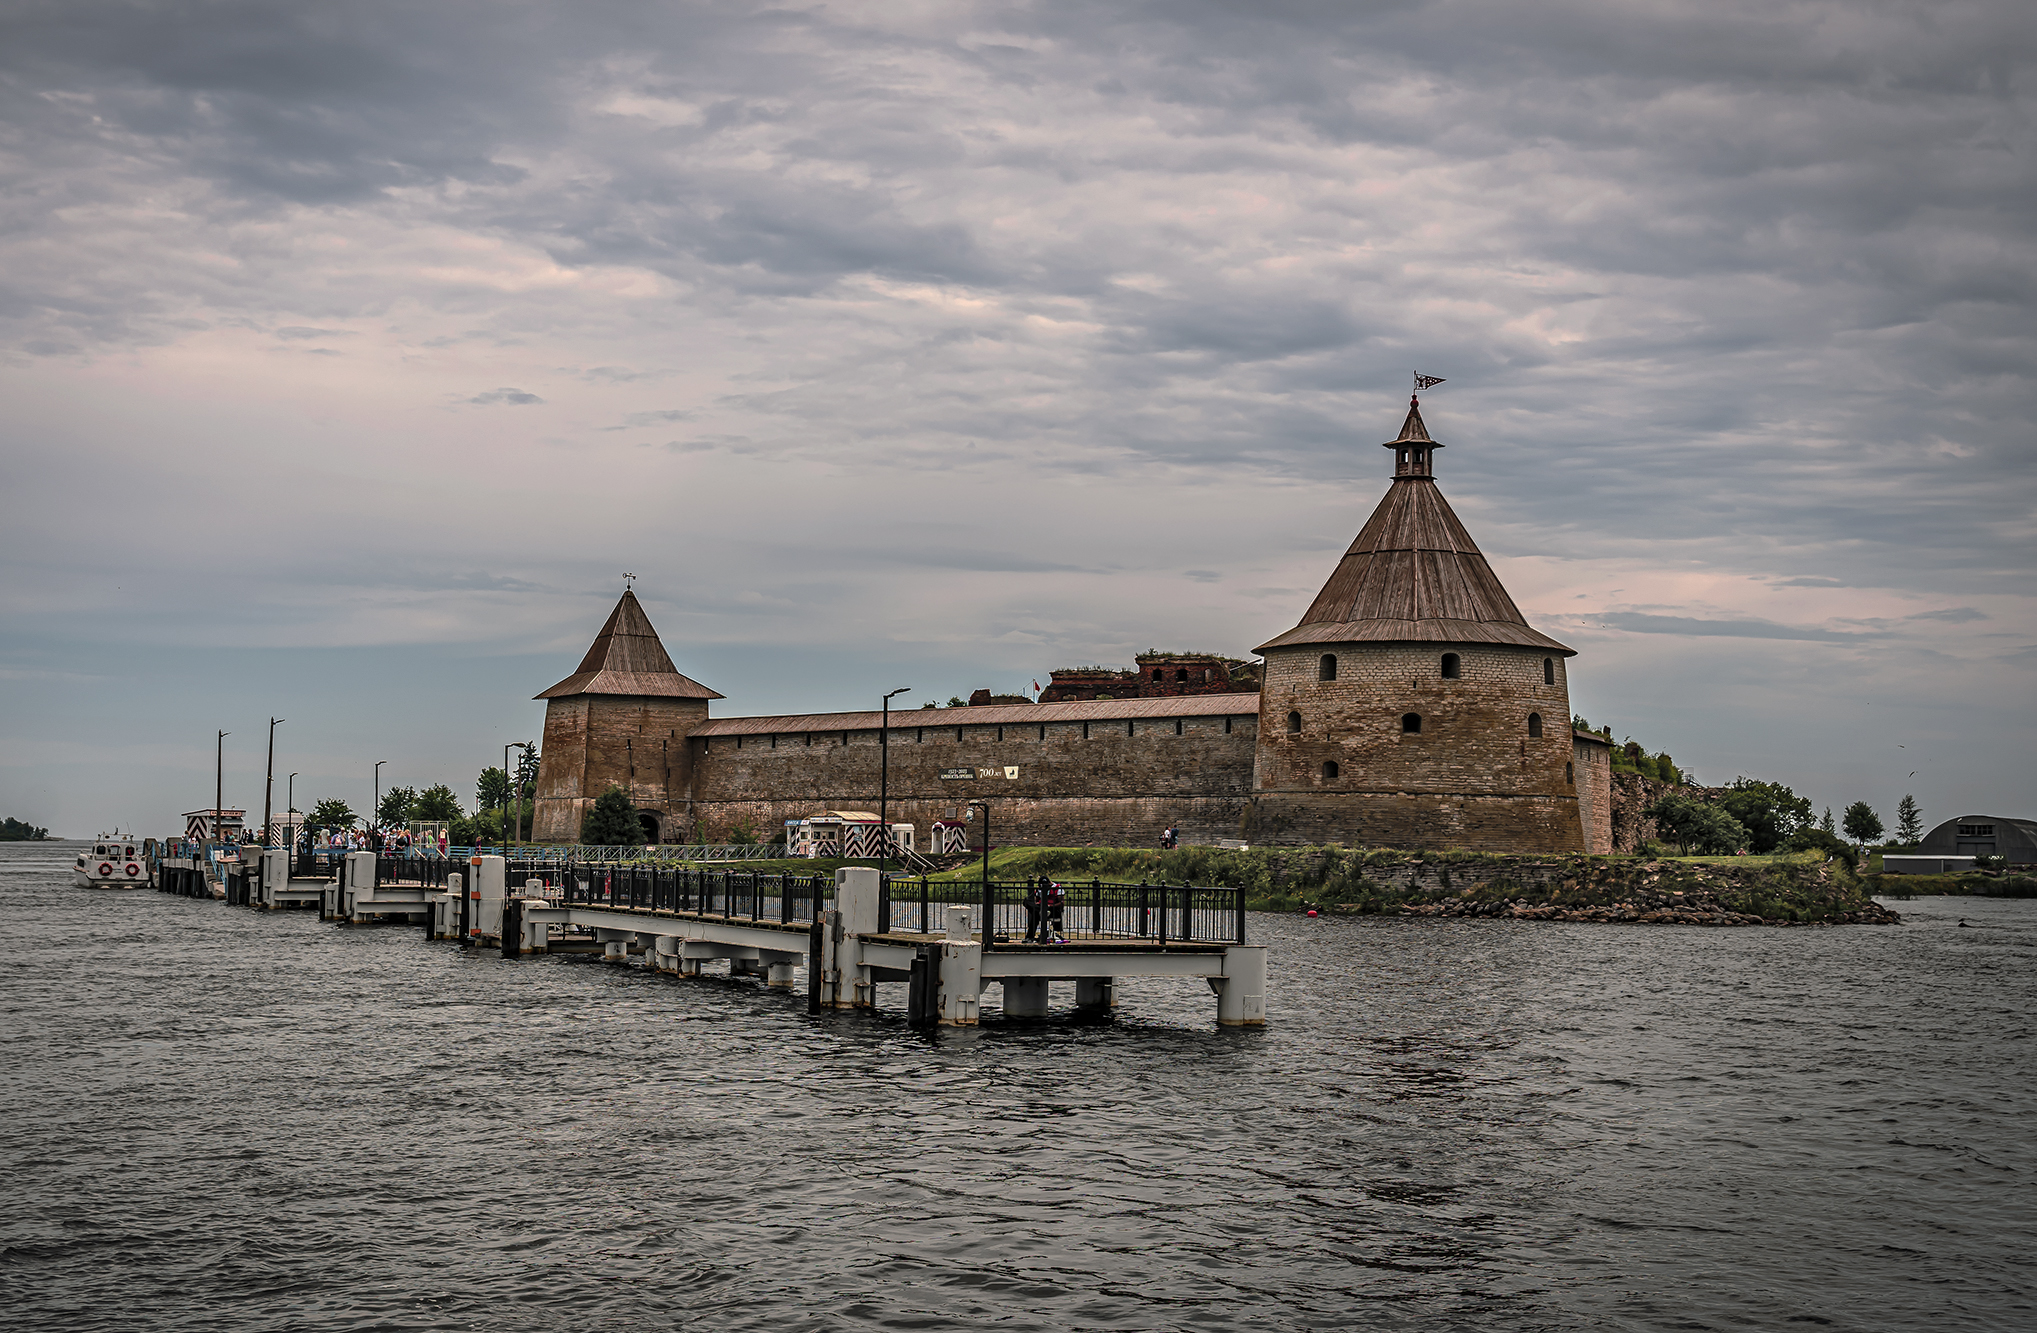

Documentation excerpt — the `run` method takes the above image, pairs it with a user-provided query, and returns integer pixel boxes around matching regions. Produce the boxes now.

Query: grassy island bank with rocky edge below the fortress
[676,846,1901,925]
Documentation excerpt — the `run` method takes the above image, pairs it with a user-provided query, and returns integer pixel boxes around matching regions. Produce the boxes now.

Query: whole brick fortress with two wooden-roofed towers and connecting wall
[536,402,1611,852]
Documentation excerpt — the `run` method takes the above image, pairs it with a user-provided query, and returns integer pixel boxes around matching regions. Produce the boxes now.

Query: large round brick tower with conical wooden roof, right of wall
[1243,399,1587,852]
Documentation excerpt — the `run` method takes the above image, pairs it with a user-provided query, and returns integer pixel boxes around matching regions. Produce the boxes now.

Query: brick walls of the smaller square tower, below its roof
[532,695,707,842]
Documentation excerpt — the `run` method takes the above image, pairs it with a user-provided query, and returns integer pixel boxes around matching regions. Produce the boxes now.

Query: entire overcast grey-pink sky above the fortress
[0,0,2037,834]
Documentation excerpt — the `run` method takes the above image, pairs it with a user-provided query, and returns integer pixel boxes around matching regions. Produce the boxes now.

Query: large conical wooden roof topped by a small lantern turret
[1255,408,1577,656]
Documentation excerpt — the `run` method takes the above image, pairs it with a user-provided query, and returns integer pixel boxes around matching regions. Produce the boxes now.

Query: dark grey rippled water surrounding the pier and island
[0,844,2037,1331]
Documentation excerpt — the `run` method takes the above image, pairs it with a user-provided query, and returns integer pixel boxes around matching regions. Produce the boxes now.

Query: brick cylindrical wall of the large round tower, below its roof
[1245,644,1585,852]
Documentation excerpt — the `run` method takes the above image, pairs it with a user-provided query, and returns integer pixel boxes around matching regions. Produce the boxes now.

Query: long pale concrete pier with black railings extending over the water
[214,850,1267,1027]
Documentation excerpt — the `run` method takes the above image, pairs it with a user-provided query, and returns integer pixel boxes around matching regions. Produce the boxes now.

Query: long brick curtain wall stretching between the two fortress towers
[684,715,1257,846]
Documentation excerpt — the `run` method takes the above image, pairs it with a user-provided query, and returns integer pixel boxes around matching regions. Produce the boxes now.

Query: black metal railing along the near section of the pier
[507,858,1245,946]
